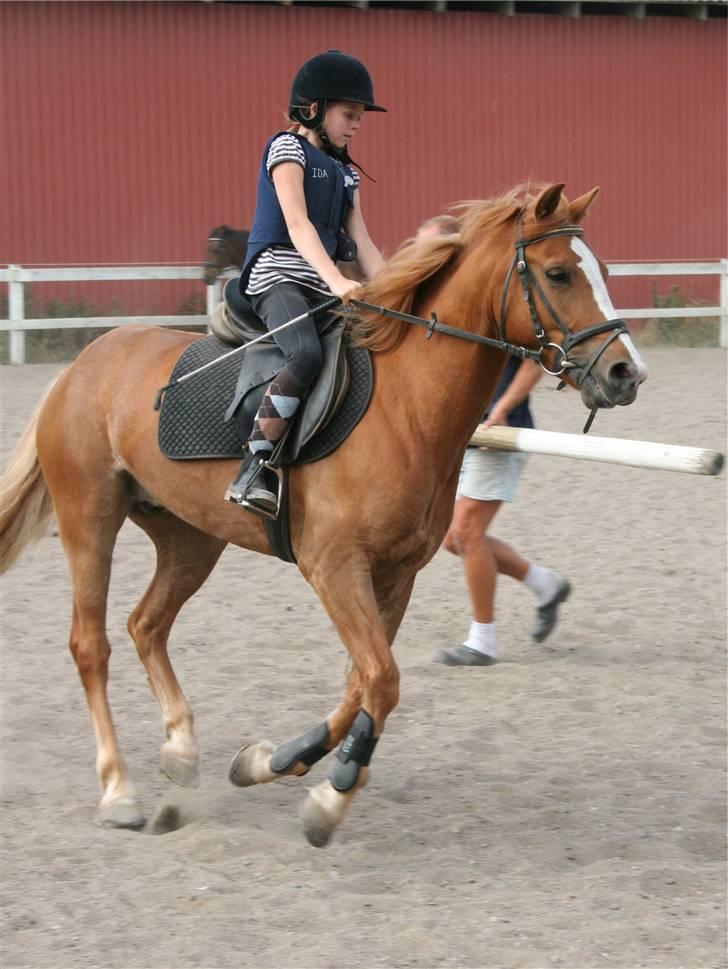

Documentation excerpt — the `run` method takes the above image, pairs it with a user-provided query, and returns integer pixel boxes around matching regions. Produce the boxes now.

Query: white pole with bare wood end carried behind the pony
[470,427,724,474]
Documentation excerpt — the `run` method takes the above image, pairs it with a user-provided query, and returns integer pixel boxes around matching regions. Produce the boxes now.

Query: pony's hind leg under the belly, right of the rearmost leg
[128,508,226,787]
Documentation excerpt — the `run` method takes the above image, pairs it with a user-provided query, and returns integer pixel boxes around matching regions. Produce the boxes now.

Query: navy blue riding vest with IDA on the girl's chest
[240,131,354,294]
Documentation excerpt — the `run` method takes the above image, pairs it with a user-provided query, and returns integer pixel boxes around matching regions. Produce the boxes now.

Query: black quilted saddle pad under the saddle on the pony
[158,336,373,464]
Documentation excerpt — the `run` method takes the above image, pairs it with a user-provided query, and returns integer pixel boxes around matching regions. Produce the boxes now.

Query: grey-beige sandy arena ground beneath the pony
[0,349,726,969]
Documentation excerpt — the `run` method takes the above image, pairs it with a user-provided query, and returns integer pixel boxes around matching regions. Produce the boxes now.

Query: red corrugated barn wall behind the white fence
[0,2,728,312]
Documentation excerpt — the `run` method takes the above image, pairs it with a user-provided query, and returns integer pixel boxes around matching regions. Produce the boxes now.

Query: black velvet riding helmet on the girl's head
[289,50,387,128]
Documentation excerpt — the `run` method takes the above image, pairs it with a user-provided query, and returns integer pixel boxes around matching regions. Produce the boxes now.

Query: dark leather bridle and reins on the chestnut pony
[350,225,628,434]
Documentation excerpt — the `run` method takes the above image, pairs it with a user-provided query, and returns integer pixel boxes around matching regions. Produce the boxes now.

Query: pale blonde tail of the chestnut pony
[0,388,53,575]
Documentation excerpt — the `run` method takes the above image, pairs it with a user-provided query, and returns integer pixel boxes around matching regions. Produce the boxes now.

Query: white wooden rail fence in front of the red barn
[0,259,728,364]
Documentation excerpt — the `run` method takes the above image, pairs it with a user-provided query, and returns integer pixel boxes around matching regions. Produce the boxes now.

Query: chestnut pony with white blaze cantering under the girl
[0,185,646,845]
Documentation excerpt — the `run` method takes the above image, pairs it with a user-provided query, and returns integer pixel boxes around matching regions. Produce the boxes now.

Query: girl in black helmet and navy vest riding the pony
[225,50,386,514]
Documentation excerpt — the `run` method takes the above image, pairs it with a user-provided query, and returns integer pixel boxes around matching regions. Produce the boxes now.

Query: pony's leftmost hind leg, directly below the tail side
[53,478,144,828]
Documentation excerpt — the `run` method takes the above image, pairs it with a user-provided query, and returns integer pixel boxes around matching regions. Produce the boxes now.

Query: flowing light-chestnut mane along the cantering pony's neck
[352,186,535,353]
